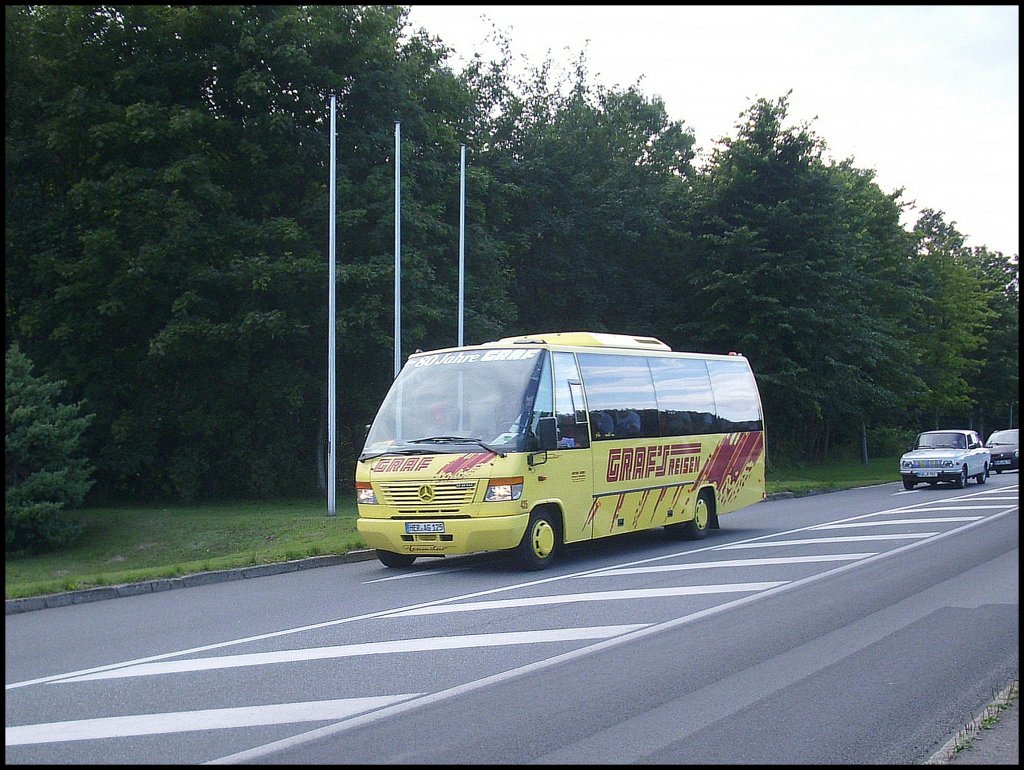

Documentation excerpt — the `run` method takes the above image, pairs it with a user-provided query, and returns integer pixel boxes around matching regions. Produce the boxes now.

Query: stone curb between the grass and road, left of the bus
[4,549,377,615]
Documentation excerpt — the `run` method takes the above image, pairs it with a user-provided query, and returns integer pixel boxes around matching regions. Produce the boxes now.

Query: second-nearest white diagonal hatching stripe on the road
[54,624,646,684]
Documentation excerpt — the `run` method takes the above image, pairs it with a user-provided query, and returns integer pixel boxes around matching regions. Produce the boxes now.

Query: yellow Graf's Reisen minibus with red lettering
[355,332,765,569]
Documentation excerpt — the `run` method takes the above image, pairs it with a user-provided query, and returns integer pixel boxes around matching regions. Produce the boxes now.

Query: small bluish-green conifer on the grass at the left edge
[4,344,92,553]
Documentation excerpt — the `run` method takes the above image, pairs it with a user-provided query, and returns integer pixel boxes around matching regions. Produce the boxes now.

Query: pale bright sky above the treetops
[408,4,1020,256]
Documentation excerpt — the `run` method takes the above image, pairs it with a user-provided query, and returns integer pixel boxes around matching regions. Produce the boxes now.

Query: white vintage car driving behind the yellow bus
[899,429,992,489]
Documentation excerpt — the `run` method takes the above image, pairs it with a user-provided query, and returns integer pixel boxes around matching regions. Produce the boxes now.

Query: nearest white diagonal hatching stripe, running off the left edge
[4,692,422,746]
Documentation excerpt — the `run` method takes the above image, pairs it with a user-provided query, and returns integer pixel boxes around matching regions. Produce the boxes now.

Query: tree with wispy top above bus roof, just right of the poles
[462,44,694,335]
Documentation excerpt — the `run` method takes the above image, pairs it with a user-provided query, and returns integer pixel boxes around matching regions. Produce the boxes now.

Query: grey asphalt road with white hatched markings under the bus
[5,473,1019,764]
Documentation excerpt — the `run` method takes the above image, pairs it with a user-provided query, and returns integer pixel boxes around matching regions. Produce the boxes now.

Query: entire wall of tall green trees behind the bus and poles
[4,5,1019,501]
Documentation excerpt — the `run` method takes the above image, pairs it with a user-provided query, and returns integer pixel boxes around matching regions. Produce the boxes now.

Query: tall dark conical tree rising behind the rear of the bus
[677,95,917,456]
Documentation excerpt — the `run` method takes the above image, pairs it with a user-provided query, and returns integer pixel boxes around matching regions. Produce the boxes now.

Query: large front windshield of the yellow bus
[359,348,547,460]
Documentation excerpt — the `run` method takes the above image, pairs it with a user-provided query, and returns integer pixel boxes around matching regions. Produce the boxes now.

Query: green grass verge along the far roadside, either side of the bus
[4,458,899,599]
